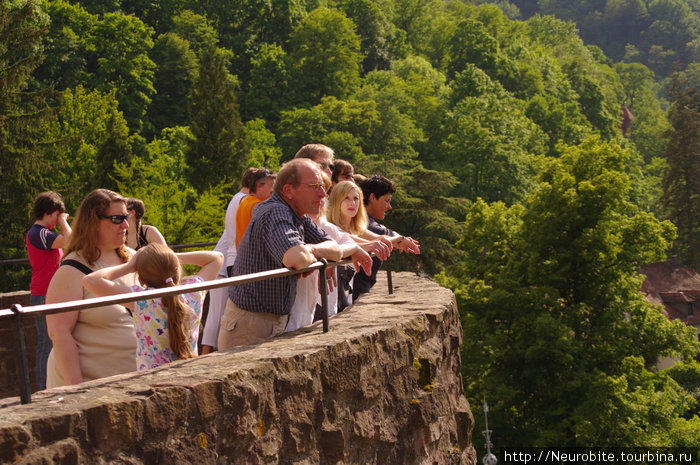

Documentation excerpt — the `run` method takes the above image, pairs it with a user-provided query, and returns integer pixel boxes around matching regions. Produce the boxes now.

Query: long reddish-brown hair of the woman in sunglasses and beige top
[64,189,131,266]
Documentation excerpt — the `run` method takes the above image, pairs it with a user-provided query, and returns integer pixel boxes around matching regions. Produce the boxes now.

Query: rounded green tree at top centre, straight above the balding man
[288,8,362,104]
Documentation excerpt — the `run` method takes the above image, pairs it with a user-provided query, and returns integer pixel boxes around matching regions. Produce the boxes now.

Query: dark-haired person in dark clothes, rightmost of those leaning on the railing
[352,174,420,302]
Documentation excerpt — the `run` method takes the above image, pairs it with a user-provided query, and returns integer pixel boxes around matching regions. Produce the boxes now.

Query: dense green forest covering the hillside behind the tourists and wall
[0,0,700,455]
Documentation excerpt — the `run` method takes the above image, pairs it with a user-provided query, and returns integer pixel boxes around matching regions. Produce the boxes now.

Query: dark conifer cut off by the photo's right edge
[662,74,700,268]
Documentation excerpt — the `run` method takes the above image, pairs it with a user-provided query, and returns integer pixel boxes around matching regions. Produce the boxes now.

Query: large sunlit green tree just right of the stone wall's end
[439,138,698,447]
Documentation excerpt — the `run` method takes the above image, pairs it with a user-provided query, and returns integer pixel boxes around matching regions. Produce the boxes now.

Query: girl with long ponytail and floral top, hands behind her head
[83,243,224,371]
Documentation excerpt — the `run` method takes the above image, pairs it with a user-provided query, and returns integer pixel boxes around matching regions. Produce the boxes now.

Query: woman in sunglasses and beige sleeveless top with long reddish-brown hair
[46,189,137,388]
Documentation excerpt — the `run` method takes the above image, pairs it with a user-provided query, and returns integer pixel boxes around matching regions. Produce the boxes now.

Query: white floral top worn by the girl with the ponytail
[131,276,206,371]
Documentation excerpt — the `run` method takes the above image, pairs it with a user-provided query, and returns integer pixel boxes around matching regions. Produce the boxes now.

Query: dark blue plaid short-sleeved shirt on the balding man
[228,193,330,315]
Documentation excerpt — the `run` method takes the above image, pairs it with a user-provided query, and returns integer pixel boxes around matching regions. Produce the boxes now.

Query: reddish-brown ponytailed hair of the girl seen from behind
[136,243,194,359]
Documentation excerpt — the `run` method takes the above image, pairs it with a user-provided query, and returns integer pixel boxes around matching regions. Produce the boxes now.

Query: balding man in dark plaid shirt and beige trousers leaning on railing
[218,159,341,350]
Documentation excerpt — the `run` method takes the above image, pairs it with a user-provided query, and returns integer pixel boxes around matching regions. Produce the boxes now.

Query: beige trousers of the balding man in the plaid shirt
[218,299,289,350]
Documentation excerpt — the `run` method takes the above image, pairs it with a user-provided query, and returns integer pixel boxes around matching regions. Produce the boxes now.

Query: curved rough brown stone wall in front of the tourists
[0,273,476,465]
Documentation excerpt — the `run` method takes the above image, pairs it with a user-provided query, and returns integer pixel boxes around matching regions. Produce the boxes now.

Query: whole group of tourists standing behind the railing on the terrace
[27,144,420,389]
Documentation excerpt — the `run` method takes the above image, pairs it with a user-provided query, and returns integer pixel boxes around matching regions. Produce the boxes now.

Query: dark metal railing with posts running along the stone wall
[0,254,393,404]
